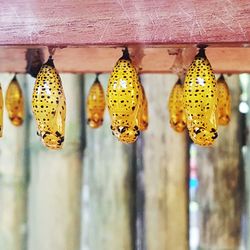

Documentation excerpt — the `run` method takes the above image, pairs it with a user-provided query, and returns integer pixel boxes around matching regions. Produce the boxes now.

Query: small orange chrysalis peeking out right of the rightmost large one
[217,75,231,125]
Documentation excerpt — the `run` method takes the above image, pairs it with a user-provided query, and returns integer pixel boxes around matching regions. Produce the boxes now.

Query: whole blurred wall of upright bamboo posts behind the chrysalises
[0,73,250,250]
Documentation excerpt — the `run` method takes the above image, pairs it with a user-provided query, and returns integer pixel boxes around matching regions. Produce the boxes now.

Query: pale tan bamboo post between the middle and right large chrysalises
[142,74,188,250]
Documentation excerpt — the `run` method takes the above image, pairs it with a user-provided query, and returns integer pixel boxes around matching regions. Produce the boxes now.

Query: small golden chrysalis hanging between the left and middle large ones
[87,74,105,128]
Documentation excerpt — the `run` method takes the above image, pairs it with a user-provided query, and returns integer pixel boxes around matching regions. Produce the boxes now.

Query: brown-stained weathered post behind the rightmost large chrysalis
[197,75,242,250]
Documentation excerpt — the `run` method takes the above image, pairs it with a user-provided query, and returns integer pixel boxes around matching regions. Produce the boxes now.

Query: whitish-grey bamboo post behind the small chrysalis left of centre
[82,75,133,250]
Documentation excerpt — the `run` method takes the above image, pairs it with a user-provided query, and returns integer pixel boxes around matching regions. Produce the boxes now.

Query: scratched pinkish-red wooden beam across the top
[0,0,250,46]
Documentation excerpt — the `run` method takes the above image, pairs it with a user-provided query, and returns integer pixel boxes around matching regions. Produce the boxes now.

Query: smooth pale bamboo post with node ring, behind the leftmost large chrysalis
[28,74,82,250]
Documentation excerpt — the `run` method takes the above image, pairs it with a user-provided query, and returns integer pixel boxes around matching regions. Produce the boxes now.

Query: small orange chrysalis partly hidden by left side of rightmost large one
[168,78,186,132]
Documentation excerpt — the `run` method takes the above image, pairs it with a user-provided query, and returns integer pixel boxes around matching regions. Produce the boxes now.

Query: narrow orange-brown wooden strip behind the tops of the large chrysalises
[0,46,250,74]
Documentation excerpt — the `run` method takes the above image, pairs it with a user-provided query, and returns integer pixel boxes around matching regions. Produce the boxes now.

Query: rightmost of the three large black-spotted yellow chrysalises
[184,48,218,146]
